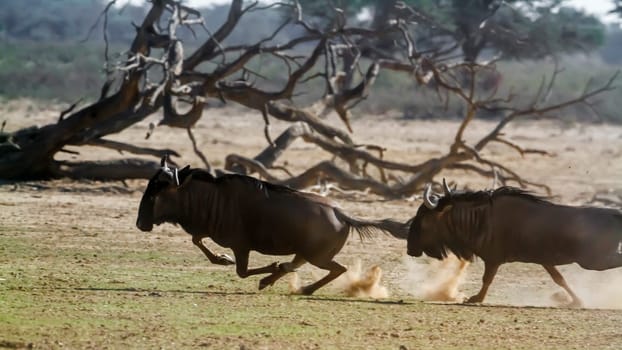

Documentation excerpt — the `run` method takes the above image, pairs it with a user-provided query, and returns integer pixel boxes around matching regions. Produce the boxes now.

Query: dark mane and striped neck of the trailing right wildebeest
[436,186,551,260]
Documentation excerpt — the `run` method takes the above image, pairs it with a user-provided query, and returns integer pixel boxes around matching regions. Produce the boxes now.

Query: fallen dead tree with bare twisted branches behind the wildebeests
[0,0,615,197]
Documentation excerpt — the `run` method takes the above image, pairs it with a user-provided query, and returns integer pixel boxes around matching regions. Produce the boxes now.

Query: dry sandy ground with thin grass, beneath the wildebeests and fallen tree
[0,103,622,349]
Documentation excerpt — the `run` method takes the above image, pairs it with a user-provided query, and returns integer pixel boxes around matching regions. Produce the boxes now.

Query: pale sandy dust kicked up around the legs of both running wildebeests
[289,255,622,309]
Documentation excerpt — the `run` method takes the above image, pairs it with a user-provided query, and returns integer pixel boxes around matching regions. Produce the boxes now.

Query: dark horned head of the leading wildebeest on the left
[136,156,188,231]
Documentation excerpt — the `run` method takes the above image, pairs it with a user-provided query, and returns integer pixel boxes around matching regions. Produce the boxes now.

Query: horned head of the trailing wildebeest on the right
[407,179,451,259]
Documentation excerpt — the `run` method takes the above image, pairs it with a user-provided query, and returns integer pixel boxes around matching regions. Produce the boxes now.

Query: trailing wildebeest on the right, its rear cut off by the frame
[407,180,622,306]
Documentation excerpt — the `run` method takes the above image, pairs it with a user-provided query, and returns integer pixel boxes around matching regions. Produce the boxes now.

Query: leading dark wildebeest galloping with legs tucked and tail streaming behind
[136,157,408,295]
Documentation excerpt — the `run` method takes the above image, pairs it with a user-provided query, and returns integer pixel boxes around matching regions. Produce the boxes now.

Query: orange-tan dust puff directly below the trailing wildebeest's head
[402,255,469,302]
